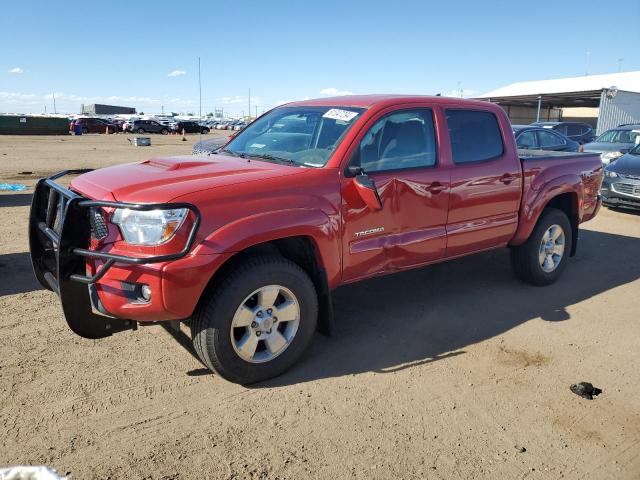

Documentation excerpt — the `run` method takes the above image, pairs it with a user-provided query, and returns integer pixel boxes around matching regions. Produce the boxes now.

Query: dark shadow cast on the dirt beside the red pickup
[254,230,640,388]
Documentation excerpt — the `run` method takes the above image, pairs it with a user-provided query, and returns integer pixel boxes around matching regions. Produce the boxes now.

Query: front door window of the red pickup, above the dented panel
[359,109,436,172]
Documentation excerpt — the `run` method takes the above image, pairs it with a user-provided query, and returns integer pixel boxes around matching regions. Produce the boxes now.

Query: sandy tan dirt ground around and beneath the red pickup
[0,135,640,479]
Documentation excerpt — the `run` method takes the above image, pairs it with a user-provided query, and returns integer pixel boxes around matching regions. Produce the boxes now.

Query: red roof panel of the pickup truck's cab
[283,94,490,108]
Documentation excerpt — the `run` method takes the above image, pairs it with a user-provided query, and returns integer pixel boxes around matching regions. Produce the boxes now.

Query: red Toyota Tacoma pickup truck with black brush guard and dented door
[30,95,603,383]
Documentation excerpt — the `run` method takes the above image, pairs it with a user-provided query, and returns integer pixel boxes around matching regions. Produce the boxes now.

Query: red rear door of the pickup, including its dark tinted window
[445,108,522,257]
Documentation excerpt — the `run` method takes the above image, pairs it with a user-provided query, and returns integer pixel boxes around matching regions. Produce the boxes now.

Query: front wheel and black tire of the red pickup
[191,256,318,385]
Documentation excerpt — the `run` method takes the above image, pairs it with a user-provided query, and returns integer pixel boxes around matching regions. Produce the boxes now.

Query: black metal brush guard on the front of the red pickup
[29,169,200,338]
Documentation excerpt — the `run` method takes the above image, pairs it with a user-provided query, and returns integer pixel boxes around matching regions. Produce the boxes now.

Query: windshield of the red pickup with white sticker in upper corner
[223,107,364,167]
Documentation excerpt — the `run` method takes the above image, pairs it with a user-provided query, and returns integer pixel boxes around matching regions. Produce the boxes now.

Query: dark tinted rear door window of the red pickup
[447,110,504,163]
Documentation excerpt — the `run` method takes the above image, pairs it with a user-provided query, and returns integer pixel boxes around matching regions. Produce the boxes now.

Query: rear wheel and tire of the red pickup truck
[511,208,573,286]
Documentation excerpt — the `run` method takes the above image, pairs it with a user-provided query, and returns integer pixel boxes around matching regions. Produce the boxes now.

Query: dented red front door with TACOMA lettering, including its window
[342,108,449,281]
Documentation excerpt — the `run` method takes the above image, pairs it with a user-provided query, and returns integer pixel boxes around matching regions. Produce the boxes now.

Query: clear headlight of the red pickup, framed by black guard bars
[111,208,187,245]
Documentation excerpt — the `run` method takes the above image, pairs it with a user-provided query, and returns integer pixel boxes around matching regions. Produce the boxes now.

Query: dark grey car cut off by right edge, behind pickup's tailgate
[600,145,640,209]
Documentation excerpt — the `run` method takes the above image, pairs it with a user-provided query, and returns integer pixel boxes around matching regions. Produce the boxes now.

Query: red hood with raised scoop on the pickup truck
[71,154,307,203]
